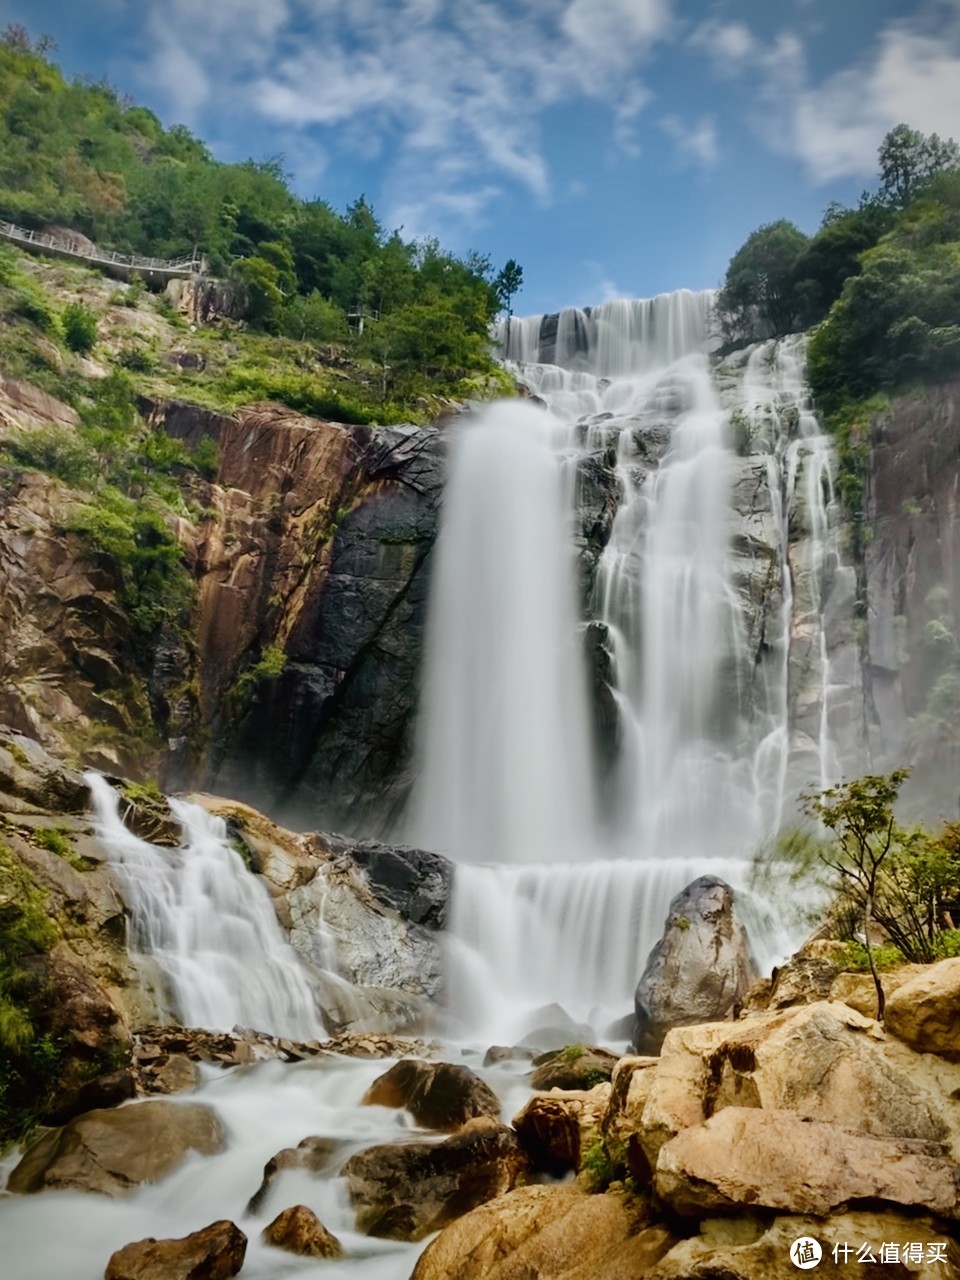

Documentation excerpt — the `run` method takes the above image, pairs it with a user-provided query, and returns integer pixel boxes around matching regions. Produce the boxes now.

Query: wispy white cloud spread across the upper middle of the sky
[128,0,675,238]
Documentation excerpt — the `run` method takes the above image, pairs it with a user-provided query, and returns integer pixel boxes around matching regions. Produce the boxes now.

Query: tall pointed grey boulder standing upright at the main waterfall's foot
[635,876,756,1053]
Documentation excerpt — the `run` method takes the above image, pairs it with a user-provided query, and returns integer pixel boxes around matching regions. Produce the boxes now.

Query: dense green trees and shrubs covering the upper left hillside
[0,27,522,422]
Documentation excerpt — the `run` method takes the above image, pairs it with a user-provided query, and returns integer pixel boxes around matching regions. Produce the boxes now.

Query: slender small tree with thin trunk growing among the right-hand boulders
[803,769,910,1020]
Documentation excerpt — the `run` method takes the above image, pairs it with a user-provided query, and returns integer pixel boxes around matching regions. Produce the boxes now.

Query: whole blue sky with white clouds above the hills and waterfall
[0,0,960,312]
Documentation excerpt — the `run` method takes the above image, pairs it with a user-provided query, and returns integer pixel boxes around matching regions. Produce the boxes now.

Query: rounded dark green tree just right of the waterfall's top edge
[717,219,808,340]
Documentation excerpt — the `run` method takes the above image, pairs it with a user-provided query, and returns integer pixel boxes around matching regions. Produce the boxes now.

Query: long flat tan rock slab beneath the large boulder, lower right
[654,1107,960,1219]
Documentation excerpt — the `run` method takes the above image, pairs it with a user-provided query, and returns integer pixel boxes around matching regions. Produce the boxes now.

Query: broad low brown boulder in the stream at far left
[6,1101,224,1196]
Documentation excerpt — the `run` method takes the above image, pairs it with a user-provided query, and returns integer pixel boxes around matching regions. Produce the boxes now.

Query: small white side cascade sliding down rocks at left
[86,773,323,1039]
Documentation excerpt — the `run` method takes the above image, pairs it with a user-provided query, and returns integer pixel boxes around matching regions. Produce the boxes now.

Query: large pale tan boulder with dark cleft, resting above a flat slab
[637,1002,960,1169]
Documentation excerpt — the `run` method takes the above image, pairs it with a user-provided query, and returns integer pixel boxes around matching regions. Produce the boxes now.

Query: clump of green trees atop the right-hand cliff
[718,124,960,425]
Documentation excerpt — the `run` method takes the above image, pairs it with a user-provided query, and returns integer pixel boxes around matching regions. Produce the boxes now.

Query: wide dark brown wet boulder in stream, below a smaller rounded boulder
[340,1119,527,1240]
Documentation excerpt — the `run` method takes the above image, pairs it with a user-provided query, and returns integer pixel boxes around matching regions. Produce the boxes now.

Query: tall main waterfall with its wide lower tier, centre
[415,292,829,1038]
